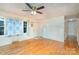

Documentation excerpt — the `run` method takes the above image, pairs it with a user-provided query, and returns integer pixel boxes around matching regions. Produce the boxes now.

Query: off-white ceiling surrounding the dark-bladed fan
[0,3,79,19]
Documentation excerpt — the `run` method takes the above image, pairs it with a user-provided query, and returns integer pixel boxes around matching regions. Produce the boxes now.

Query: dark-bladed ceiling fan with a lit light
[22,3,45,15]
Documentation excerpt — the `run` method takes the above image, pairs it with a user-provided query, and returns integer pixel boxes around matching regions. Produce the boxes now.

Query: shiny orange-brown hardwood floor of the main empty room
[0,38,79,55]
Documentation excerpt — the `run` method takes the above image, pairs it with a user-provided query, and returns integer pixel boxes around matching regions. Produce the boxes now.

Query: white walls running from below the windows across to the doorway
[0,16,64,46]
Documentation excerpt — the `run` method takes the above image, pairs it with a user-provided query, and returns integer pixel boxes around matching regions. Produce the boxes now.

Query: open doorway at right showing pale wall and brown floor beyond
[65,19,78,48]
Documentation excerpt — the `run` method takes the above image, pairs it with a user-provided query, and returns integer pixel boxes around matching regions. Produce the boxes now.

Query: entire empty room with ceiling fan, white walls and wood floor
[0,3,79,55]
